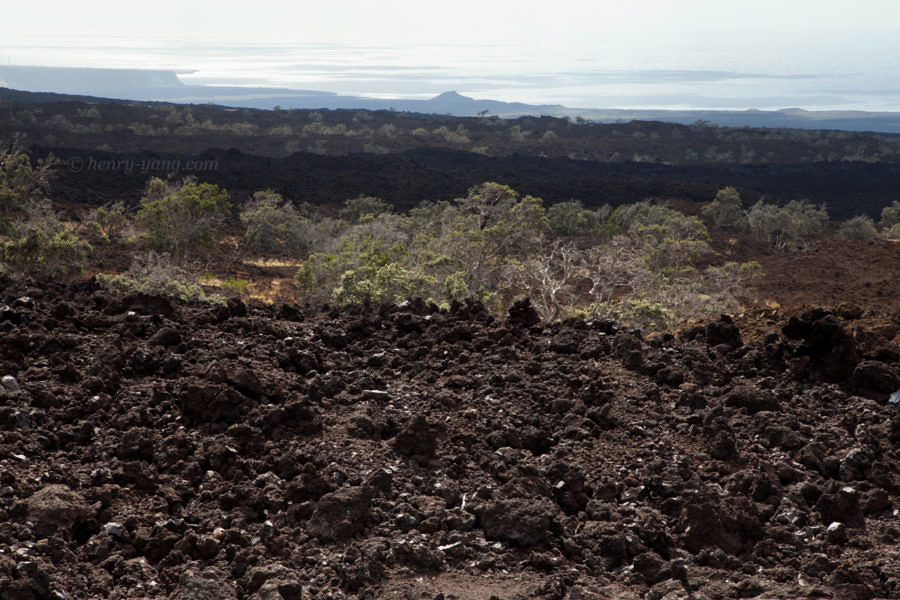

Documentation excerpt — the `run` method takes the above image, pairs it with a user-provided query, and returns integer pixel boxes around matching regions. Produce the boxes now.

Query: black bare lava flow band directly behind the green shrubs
[32,146,900,220]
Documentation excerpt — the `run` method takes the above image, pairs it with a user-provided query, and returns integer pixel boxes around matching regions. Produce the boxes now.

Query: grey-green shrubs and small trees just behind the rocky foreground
[0,136,900,328]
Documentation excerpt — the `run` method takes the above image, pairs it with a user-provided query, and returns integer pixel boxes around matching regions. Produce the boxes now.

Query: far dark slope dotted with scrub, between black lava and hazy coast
[7,97,900,164]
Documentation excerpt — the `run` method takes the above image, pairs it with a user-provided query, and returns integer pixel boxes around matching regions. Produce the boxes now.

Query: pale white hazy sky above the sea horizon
[0,0,900,50]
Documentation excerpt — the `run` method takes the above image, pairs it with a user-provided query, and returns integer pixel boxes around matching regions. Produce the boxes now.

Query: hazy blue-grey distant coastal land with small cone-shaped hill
[0,66,900,133]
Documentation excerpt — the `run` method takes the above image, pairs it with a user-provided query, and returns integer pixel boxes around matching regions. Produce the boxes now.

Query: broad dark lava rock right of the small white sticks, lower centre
[476,498,556,547]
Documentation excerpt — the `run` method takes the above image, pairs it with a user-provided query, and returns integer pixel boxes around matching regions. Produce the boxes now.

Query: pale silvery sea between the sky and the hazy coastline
[0,37,900,111]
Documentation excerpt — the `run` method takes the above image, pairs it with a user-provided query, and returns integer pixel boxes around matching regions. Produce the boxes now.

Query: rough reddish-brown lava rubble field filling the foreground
[0,284,900,600]
